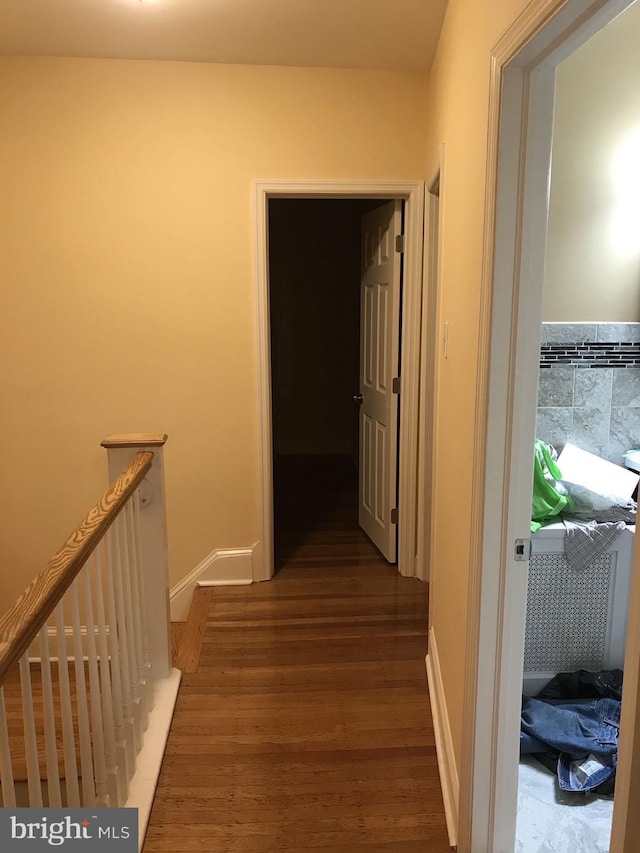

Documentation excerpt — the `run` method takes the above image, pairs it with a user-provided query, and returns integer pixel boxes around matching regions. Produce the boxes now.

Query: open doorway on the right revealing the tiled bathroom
[516,5,640,853]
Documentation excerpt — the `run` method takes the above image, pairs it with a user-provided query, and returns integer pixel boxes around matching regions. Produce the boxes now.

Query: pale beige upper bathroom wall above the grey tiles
[544,3,640,322]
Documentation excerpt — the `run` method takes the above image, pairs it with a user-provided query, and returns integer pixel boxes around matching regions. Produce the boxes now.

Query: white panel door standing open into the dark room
[359,201,402,563]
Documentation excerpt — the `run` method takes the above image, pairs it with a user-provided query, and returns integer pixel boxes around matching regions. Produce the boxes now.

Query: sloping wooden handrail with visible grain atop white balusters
[0,450,153,685]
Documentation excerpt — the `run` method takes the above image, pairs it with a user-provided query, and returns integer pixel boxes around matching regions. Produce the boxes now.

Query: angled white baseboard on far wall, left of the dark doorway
[169,548,253,622]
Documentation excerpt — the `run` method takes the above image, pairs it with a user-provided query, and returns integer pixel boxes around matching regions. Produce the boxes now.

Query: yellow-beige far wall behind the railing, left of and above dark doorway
[0,58,427,604]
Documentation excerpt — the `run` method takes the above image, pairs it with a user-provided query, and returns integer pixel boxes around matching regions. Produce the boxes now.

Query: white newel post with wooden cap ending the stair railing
[101,433,171,679]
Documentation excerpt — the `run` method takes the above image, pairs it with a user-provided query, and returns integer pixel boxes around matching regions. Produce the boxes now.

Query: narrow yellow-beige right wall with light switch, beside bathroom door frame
[425,0,526,774]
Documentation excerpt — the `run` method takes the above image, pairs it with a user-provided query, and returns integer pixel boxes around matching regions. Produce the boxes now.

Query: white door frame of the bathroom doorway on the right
[458,0,640,853]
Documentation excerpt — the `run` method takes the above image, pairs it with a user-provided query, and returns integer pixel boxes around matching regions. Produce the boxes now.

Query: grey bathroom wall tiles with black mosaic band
[536,323,640,465]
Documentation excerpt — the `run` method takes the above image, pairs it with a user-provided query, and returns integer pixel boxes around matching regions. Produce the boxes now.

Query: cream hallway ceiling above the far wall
[0,0,447,69]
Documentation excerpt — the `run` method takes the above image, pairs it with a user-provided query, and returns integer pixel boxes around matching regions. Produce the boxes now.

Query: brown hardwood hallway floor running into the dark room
[144,459,449,853]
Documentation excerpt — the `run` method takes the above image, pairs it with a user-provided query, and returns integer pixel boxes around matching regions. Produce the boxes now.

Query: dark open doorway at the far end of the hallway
[269,199,392,571]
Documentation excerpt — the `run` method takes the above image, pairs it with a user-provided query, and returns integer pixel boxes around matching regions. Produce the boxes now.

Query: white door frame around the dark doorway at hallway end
[253,180,424,581]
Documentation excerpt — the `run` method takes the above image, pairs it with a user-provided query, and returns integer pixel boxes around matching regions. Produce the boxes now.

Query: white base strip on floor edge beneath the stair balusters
[125,669,182,851]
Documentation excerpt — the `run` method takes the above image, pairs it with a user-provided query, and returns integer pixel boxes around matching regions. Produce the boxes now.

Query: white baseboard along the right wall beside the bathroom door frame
[425,628,460,847]
